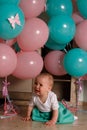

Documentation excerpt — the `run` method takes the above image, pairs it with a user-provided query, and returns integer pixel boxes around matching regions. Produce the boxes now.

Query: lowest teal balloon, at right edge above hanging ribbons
[63,48,87,77]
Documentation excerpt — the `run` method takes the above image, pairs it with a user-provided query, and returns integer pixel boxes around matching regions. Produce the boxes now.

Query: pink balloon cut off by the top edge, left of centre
[19,0,45,19]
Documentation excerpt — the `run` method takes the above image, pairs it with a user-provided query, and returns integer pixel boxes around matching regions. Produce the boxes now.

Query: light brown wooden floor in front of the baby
[0,108,87,130]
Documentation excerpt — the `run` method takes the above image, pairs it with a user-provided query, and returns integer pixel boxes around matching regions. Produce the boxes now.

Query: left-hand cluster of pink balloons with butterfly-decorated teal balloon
[0,0,49,79]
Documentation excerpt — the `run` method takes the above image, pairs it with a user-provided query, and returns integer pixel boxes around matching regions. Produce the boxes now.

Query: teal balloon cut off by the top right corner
[76,0,87,19]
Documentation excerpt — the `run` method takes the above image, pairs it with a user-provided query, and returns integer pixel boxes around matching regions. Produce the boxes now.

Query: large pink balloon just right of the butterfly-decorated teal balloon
[17,18,49,51]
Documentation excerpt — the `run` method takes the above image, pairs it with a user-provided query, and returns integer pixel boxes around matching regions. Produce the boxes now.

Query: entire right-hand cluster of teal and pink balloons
[44,0,87,77]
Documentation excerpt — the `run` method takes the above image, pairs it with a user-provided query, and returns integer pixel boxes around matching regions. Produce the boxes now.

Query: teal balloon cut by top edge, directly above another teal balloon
[46,0,73,17]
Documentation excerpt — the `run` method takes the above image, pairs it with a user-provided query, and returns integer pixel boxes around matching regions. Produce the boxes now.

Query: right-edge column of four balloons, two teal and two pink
[64,0,87,77]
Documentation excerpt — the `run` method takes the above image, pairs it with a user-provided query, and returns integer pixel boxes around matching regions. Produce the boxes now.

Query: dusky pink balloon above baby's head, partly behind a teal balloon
[44,51,66,76]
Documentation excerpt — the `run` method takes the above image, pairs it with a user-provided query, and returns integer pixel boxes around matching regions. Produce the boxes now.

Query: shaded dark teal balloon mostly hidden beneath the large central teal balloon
[45,37,66,50]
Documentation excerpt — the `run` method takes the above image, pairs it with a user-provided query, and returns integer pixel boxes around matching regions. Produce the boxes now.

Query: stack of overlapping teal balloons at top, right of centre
[46,0,76,50]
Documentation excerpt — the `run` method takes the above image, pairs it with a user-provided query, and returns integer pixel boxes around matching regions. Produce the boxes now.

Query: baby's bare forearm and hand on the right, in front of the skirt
[46,110,58,126]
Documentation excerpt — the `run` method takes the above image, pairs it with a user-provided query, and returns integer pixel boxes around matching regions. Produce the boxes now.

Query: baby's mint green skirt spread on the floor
[32,102,74,124]
